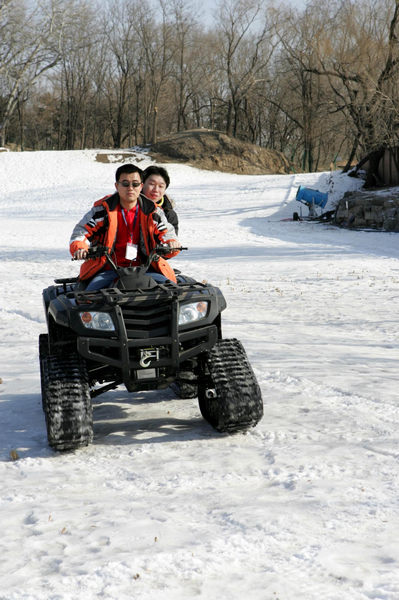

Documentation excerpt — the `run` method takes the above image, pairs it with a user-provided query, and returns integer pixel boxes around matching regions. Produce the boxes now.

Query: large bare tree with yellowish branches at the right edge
[282,0,399,174]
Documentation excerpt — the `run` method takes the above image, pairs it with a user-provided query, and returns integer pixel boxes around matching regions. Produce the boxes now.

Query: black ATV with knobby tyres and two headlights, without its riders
[39,247,263,450]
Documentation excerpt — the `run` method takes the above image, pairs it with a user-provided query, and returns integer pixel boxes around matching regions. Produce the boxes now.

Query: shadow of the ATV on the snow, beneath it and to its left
[0,390,221,462]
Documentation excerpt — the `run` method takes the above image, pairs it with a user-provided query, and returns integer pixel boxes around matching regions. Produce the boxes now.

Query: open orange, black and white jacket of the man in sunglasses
[69,193,179,282]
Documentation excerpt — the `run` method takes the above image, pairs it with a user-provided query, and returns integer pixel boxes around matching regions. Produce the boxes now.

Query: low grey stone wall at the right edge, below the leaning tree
[335,190,399,232]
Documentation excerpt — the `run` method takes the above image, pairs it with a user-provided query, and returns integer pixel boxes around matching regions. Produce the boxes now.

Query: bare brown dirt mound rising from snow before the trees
[149,129,290,175]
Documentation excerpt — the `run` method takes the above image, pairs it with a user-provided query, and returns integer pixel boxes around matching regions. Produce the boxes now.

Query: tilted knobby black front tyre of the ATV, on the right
[198,338,263,433]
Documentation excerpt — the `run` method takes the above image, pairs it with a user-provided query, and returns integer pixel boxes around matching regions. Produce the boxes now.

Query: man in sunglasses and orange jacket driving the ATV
[70,164,180,291]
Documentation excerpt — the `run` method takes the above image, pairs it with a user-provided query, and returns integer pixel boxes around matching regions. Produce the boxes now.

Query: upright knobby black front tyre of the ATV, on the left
[41,352,93,450]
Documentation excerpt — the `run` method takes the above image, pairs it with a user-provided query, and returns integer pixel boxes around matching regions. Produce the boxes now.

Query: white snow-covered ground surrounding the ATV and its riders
[0,146,399,600]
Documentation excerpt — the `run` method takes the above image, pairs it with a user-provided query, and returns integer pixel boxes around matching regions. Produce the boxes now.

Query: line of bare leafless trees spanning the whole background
[0,0,399,176]
